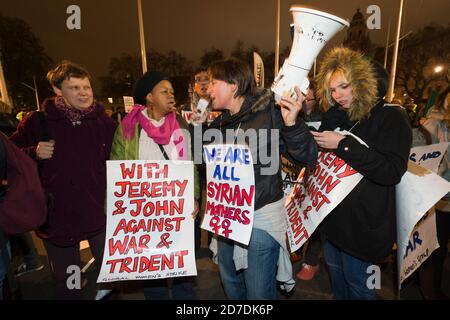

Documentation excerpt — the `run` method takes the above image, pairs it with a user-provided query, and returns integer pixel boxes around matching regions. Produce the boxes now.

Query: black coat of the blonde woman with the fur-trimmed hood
[320,101,412,262]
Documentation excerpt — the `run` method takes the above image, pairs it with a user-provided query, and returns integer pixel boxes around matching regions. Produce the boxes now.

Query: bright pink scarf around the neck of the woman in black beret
[122,104,188,160]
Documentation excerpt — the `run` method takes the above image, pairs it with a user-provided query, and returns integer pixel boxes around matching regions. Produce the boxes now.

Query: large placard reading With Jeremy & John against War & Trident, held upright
[97,160,197,282]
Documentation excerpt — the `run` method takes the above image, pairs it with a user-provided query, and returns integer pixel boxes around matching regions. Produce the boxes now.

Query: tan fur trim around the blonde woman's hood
[317,47,377,121]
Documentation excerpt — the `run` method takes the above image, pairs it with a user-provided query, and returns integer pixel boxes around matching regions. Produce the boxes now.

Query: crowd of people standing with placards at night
[0,47,450,300]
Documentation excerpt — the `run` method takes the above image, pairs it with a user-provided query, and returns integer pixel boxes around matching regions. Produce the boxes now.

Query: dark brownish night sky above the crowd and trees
[0,0,450,87]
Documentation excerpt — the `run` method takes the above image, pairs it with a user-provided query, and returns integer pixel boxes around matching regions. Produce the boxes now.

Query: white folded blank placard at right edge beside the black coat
[395,161,450,288]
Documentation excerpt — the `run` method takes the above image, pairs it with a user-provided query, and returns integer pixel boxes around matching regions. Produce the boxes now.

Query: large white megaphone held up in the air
[271,6,349,103]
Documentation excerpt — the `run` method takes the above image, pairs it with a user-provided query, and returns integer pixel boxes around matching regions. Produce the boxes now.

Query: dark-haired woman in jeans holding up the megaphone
[204,59,317,300]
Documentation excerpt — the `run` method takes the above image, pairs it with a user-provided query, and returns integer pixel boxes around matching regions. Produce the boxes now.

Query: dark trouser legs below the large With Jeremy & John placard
[144,277,196,300]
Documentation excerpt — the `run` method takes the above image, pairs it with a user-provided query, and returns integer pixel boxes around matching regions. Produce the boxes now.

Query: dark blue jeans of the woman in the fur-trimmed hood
[323,241,376,300]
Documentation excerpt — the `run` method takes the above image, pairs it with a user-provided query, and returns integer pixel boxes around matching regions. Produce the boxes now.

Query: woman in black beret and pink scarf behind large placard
[110,71,200,300]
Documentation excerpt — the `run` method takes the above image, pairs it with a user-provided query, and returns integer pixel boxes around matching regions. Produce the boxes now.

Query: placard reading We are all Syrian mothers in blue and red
[202,144,255,245]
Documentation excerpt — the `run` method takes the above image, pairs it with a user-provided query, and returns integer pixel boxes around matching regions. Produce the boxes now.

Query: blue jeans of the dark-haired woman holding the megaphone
[218,229,280,300]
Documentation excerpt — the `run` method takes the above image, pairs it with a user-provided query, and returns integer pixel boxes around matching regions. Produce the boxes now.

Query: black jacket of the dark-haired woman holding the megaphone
[205,90,318,210]
